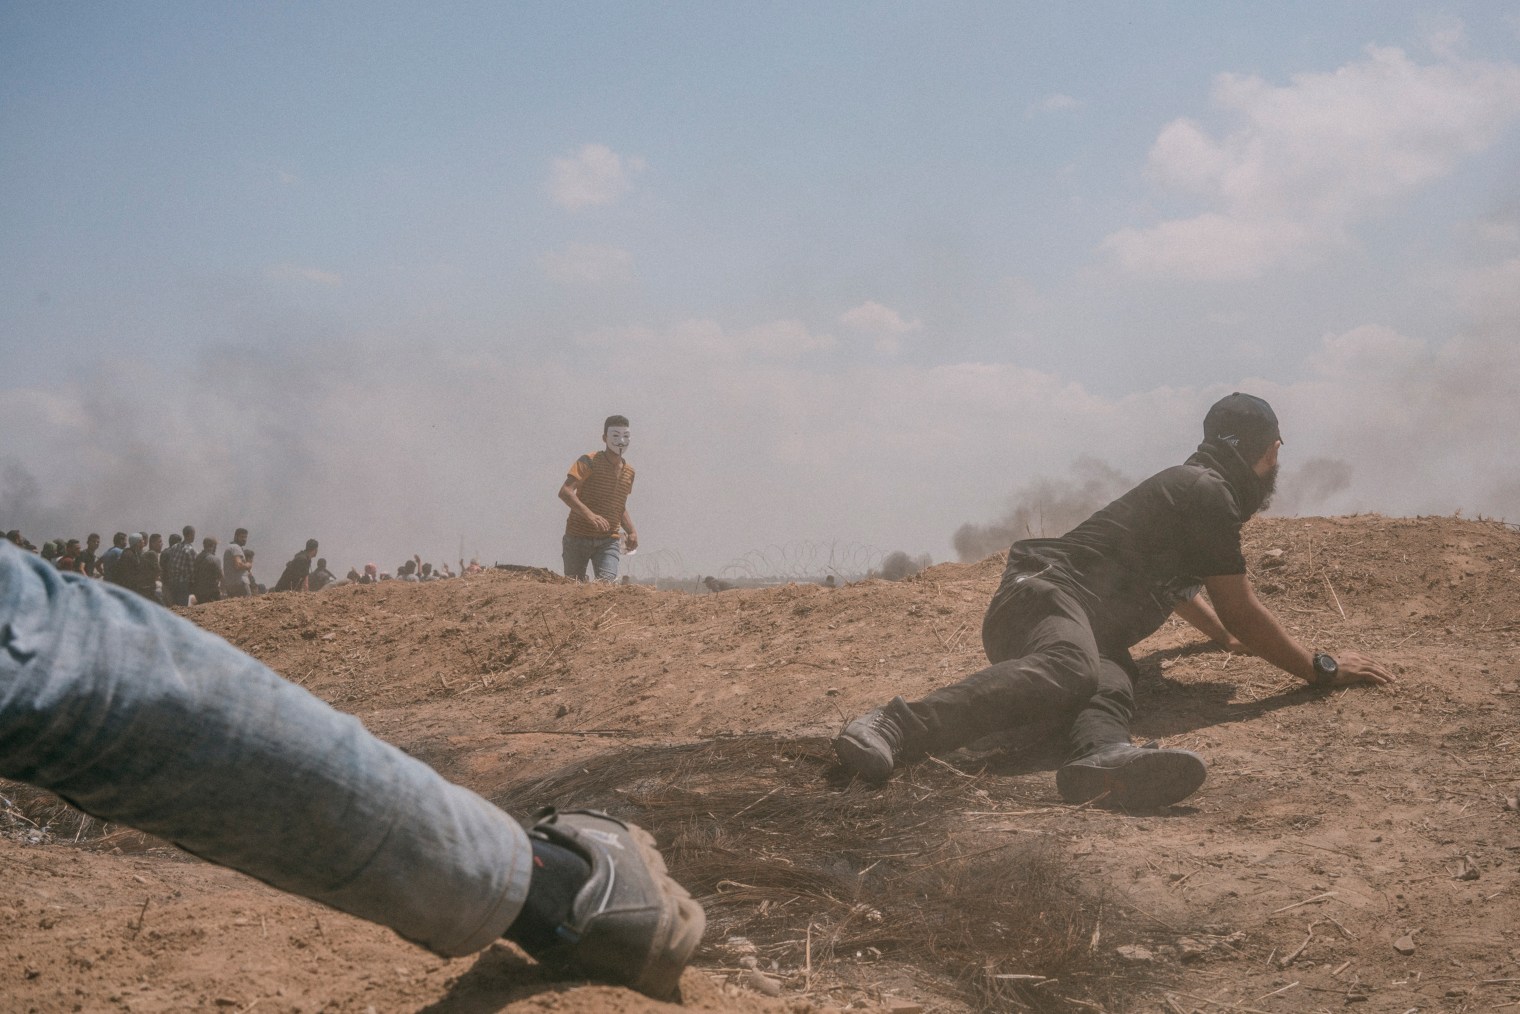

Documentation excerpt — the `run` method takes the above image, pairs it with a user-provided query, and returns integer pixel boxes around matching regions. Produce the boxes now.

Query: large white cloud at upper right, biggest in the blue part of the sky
[1104,46,1520,278]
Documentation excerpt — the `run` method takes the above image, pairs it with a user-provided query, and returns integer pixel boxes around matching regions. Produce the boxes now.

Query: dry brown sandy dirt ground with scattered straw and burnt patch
[0,515,1520,1014]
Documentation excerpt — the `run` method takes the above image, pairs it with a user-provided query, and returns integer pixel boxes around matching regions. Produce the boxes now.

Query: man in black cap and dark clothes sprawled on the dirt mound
[834,392,1394,809]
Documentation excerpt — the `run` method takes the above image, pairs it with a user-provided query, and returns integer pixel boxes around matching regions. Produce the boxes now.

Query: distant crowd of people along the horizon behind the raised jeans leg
[5,524,483,607]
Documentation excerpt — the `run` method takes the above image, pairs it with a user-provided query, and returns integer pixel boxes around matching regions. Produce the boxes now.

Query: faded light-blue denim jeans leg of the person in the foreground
[0,543,532,956]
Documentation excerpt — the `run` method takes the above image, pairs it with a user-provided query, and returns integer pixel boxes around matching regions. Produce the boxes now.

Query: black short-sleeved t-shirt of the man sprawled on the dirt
[1003,448,1259,651]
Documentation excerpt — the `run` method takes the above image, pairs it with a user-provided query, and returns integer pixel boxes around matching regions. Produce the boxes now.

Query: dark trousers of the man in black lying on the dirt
[909,564,1134,760]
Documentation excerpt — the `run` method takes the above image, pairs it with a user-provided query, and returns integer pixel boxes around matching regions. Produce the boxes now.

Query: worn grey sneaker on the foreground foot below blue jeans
[527,809,707,997]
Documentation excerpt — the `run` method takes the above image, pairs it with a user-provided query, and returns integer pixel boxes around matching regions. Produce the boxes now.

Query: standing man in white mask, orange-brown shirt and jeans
[559,415,638,581]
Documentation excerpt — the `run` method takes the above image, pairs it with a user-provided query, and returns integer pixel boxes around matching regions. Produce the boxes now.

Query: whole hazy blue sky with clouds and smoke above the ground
[0,2,1520,572]
